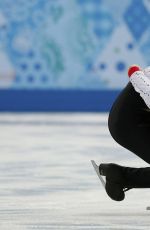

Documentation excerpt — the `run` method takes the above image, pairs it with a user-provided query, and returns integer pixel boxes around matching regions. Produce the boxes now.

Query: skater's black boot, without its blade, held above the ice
[99,163,131,201]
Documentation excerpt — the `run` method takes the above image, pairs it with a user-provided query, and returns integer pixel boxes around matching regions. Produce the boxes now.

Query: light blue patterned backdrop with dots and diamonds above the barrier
[0,0,150,89]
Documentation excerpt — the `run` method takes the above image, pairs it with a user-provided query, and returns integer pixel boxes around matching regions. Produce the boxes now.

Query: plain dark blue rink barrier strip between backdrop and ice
[0,90,120,112]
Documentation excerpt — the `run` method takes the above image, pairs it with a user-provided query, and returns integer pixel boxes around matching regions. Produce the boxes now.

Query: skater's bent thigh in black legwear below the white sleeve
[108,83,150,163]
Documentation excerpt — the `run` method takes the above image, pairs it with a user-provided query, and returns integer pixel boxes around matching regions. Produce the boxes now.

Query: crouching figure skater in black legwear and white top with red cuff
[92,65,150,201]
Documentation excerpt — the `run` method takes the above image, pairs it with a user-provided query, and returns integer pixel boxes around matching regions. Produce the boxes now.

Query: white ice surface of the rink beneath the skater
[0,113,150,230]
